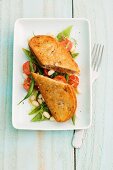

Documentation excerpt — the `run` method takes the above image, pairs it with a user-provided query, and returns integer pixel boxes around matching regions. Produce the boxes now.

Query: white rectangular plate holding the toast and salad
[12,18,92,130]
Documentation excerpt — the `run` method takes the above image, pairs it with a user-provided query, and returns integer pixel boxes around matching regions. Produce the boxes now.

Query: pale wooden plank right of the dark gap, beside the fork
[74,0,113,170]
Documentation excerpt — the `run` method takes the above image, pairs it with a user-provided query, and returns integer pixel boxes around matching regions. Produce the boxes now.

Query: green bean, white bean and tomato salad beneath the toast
[19,26,80,124]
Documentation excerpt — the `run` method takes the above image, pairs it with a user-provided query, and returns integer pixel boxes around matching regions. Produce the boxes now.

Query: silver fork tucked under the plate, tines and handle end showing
[72,44,104,148]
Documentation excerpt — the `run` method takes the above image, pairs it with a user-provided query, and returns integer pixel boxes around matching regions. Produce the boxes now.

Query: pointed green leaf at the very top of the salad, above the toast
[57,26,73,41]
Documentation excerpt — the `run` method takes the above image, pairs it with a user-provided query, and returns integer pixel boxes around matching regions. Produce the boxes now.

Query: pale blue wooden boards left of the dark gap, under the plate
[0,0,74,170]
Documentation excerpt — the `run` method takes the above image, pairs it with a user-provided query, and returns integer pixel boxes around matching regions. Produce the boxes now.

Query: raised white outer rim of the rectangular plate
[12,17,92,131]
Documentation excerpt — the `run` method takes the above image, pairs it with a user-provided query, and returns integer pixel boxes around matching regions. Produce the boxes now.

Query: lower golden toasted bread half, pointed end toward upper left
[32,73,77,122]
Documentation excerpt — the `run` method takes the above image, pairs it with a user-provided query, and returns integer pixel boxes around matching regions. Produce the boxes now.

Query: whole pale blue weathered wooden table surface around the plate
[0,0,113,170]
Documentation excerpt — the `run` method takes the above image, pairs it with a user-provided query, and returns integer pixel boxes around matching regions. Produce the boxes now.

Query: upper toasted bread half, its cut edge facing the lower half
[29,35,79,73]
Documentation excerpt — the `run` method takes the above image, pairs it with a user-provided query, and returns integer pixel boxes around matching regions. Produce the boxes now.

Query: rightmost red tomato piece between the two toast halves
[68,75,79,88]
